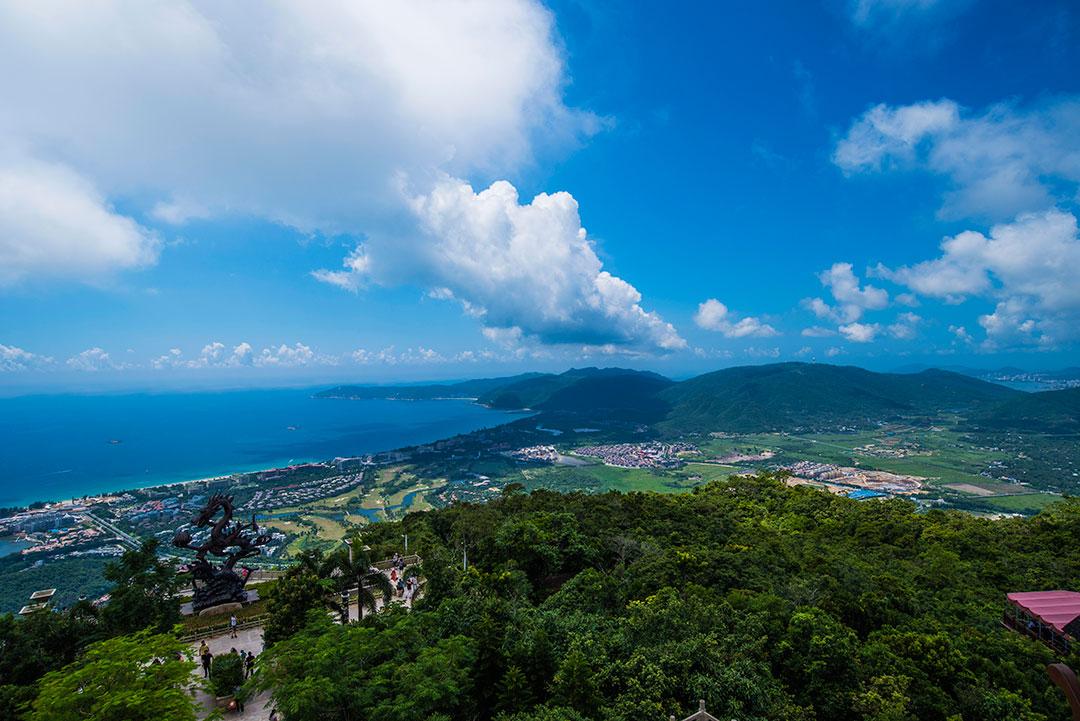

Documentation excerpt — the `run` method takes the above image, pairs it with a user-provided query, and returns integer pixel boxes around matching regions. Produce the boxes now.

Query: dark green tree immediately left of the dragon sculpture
[102,539,180,635]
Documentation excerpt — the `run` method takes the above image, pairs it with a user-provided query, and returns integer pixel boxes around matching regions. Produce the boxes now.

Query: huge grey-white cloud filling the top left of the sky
[0,0,598,231]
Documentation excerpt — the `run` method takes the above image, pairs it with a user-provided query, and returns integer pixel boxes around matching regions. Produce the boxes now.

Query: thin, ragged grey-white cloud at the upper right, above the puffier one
[833,98,1080,220]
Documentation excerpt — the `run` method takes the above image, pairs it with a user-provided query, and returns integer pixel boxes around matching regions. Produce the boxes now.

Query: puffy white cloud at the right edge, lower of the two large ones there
[878,210,1080,345]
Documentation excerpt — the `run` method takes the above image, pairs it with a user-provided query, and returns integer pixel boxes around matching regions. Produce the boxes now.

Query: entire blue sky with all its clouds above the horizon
[0,0,1080,392]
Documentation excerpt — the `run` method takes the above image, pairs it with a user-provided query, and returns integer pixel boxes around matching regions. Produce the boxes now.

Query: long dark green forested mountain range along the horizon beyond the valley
[320,363,1024,433]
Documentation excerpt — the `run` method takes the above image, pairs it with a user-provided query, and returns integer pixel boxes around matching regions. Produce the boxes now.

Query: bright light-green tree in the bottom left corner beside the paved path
[29,631,198,721]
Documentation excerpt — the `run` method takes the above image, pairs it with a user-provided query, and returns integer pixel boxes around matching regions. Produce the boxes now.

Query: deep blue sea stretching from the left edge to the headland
[0,389,519,506]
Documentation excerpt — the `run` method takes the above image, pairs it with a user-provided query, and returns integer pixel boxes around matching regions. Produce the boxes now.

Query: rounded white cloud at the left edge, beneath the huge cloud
[0,158,159,286]
